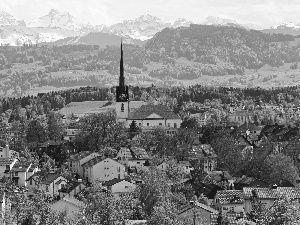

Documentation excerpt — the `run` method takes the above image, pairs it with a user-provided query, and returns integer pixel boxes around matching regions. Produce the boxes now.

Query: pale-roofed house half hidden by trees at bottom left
[51,195,85,219]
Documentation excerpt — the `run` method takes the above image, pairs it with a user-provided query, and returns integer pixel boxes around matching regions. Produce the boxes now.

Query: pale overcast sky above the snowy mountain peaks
[0,0,300,27]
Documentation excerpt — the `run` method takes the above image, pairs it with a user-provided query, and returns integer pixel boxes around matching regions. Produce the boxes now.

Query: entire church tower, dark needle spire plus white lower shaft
[116,40,129,122]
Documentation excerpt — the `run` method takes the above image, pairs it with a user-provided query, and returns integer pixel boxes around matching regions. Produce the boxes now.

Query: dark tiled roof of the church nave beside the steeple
[128,105,180,120]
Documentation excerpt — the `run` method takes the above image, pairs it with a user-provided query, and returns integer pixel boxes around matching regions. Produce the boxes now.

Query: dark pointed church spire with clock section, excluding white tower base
[116,40,129,102]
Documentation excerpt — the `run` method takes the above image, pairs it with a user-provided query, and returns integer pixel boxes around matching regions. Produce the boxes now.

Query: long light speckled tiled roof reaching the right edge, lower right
[243,187,300,199]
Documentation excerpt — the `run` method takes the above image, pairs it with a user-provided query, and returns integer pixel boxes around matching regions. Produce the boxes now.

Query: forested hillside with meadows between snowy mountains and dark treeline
[0,25,300,97]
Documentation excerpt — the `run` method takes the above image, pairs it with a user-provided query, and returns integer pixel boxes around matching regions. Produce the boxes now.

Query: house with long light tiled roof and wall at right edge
[243,186,300,213]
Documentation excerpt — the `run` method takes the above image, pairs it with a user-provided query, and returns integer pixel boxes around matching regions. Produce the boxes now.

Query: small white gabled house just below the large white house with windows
[102,178,136,197]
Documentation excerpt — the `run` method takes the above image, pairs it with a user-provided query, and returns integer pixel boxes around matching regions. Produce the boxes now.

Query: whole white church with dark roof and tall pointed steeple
[116,42,182,135]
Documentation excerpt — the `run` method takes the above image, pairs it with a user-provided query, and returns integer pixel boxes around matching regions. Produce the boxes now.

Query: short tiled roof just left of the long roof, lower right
[217,190,244,205]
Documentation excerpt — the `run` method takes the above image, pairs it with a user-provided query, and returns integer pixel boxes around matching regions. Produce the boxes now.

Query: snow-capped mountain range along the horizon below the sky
[0,9,300,46]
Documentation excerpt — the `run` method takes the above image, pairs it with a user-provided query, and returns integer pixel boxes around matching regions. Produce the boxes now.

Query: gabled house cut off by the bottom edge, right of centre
[177,202,219,225]
